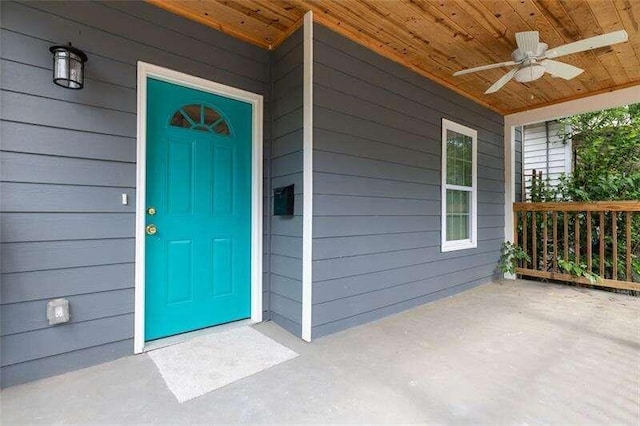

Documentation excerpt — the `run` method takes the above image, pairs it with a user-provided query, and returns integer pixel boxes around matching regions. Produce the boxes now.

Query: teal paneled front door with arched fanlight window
[145,78,252,340]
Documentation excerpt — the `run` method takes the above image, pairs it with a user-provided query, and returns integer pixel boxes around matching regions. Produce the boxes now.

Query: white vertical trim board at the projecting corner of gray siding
[302,11,313,342]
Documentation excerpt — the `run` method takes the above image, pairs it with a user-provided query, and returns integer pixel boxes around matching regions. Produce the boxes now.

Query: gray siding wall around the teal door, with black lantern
[0,2,270,386]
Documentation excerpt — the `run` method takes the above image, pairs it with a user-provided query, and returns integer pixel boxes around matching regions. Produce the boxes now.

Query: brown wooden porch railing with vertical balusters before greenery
[513,201,640,291]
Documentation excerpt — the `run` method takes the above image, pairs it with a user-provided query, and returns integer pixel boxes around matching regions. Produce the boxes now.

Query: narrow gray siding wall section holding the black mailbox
[268,29,303,336]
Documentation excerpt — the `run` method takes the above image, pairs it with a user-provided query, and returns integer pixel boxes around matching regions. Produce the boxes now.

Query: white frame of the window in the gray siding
[440,118,478,252]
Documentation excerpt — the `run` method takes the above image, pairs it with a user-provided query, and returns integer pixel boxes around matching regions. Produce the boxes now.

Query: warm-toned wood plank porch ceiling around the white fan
[148,0,640,114]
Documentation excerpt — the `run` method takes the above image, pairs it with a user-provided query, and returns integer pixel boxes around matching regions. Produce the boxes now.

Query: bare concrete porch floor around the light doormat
[0,281,640,425]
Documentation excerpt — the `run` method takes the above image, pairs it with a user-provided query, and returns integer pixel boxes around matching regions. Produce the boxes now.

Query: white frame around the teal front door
[133,61,263,353]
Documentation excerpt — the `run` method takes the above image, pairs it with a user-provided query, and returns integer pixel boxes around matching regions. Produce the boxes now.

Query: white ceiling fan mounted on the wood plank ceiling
[453,30,629,94]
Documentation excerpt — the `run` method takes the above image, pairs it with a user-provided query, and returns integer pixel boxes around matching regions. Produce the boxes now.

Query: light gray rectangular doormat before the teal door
[149,327,298,403]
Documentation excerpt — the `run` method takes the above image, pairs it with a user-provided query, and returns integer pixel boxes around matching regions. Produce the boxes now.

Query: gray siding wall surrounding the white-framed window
[313,25,504,337]
